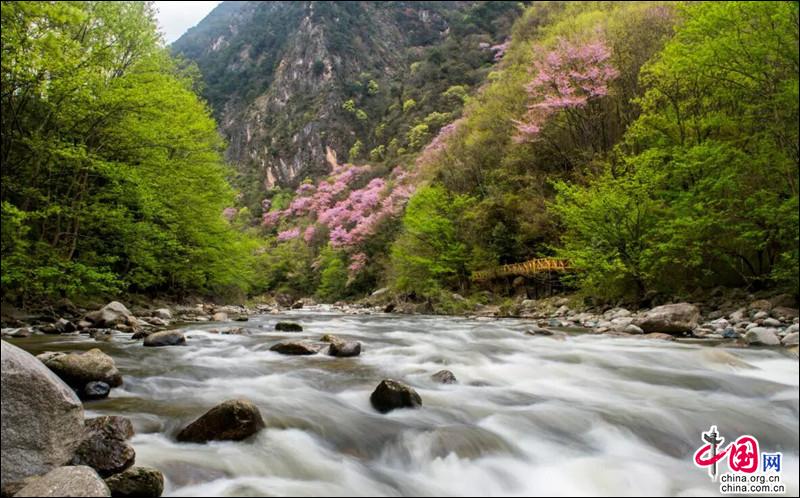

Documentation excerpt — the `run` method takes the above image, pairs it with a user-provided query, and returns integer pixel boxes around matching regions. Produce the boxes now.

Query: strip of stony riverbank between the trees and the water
[0,289,800,356]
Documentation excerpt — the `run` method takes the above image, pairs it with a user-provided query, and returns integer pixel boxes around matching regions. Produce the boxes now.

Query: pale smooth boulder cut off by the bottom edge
[14,465,111,497]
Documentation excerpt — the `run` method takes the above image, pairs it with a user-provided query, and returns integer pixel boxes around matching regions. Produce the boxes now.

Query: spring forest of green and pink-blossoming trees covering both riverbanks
[2,2,800,309]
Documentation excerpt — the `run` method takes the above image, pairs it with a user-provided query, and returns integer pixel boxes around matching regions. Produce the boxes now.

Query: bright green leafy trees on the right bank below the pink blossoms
[555,2,798,296]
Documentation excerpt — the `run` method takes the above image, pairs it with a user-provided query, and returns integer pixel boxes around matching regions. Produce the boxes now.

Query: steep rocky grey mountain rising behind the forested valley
[172,1,521,214]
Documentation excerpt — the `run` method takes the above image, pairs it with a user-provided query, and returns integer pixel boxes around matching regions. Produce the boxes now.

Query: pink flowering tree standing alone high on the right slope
[514,37,619,143]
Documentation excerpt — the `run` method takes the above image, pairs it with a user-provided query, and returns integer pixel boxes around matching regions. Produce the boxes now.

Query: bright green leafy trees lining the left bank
[2,2,256,301]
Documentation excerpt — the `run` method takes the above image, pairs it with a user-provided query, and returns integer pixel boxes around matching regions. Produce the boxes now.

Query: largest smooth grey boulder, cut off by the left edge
[0,341,84,495]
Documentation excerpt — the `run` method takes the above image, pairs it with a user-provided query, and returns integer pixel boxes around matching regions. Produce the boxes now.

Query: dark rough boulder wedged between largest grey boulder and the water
[72,416,136,477]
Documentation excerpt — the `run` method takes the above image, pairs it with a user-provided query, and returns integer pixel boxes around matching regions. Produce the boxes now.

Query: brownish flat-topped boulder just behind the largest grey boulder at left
[44,348,122,389]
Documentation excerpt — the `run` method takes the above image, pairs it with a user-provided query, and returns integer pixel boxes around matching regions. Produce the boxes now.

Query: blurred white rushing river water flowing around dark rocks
[14,312,798,496]
